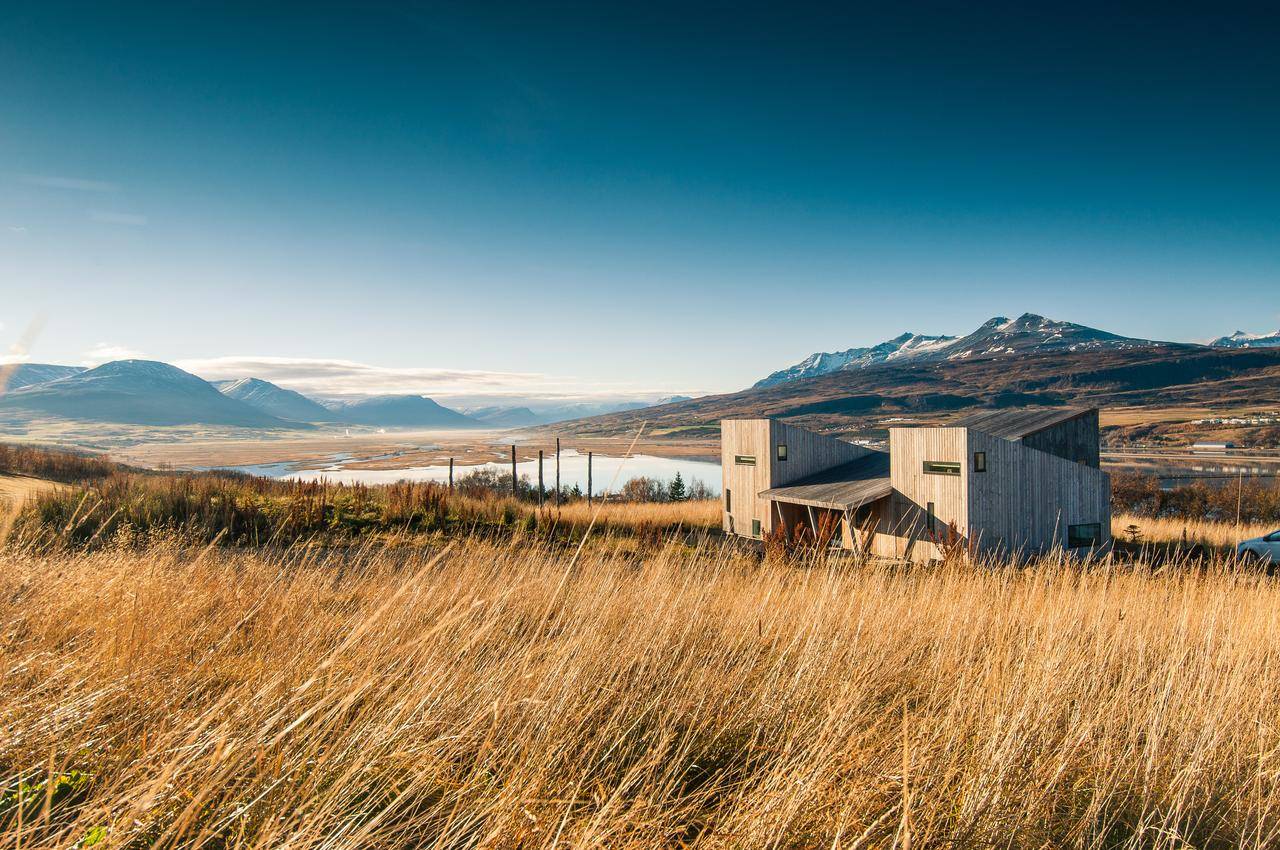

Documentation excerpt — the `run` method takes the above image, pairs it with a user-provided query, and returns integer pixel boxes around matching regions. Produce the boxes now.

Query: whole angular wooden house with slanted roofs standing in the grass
[721,408,1111,561]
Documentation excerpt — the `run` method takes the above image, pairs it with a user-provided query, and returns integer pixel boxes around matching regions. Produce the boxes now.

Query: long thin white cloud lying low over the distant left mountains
[174,356,701,401]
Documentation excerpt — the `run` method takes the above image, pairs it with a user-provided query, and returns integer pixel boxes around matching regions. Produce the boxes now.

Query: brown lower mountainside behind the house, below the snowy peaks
[570,343,1280,435]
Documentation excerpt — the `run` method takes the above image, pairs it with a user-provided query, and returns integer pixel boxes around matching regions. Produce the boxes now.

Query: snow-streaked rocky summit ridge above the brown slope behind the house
[755,312,1166,387]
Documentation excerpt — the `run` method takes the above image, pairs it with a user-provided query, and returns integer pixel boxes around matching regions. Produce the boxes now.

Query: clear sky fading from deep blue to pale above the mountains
[0,1,1280,396]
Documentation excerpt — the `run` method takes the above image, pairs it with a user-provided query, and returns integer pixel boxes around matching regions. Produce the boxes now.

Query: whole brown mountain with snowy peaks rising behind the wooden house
[575,314,1280,437]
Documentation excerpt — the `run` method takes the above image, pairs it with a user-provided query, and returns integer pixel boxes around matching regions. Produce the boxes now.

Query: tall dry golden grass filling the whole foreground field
[0,536,1280,849]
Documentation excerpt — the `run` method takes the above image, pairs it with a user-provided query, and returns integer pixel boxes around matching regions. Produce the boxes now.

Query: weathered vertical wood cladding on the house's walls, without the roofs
[721,411,1111,561]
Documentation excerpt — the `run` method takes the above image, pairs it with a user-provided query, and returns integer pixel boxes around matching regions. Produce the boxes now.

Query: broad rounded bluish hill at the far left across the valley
[0,360,302,428]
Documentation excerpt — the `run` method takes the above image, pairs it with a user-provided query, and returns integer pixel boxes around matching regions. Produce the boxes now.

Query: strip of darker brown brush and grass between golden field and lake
[14,460,719,545]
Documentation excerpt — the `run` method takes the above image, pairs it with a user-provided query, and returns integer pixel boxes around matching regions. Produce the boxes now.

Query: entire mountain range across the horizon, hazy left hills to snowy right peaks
[0,314,1280,434]
